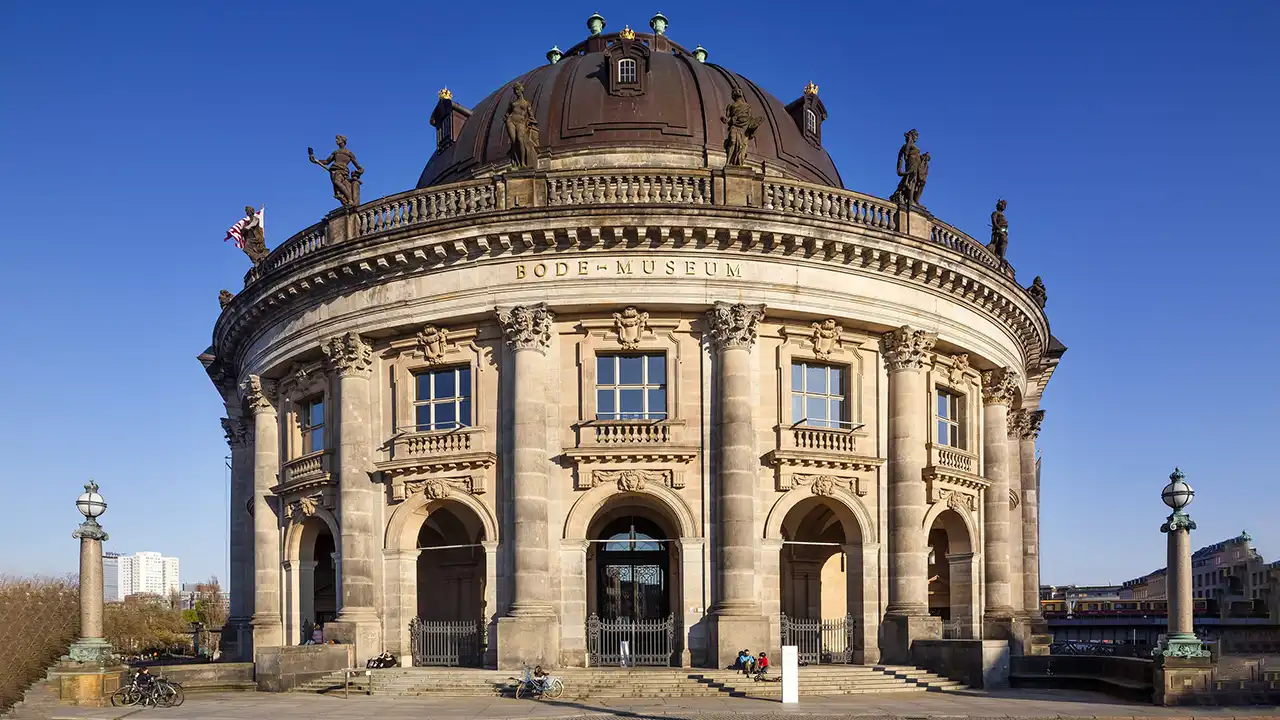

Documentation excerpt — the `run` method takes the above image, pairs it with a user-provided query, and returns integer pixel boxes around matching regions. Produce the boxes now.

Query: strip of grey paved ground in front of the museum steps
[37,691,1280,720]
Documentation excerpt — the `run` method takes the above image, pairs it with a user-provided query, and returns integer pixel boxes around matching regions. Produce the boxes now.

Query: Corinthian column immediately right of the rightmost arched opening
[982,368,1018,639]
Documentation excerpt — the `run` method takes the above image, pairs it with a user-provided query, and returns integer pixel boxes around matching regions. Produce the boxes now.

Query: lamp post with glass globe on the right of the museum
[1160,468,1210,659]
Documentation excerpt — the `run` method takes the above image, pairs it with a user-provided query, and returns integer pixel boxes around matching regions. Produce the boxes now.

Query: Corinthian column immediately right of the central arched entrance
[707,302,772,667]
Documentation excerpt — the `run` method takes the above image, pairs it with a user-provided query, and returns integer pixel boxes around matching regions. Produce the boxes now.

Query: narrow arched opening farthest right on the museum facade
[928,509,978,639]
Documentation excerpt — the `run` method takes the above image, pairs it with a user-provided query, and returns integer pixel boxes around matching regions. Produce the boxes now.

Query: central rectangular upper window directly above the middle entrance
[595,352,667,420]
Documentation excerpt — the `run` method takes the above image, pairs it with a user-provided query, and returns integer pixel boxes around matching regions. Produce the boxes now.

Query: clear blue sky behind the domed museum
[0,0,1280,583]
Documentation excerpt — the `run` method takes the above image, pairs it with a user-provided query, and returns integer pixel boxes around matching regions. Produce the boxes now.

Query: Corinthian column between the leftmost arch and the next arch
[320,333,384,659]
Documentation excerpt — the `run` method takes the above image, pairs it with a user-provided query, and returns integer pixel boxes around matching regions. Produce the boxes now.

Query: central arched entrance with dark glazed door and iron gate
[586,493,681,666]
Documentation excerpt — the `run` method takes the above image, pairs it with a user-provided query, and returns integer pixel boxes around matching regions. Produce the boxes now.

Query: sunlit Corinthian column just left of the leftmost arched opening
[241,375,284,652]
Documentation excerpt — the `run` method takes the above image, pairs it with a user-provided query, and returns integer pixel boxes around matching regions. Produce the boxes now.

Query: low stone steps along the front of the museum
[294,665,965,700]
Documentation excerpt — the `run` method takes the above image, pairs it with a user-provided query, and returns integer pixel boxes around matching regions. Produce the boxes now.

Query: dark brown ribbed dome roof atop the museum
[417,31,844,187]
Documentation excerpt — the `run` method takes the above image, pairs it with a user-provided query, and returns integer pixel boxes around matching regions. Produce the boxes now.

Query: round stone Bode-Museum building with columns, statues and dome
[200,14,1066,667]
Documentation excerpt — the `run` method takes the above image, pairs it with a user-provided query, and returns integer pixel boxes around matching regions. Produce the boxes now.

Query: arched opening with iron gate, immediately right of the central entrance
[778,496,864,664]
